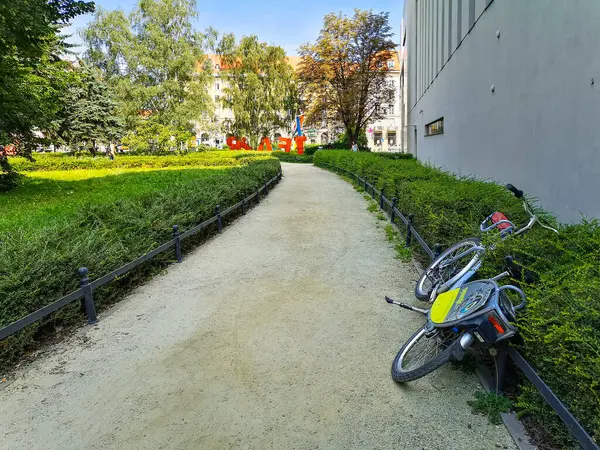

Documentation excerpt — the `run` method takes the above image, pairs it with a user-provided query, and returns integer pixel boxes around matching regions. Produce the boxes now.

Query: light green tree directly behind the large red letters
[217,34,297,146]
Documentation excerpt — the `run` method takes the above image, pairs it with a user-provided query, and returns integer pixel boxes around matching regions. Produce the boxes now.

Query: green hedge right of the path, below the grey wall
[314,151,600,448]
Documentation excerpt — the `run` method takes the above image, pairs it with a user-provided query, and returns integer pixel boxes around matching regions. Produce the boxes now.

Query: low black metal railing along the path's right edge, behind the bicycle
[322,164,600,450]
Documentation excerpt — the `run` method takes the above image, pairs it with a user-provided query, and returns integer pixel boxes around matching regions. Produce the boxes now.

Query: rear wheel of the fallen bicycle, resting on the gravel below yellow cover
[392,326,461,383]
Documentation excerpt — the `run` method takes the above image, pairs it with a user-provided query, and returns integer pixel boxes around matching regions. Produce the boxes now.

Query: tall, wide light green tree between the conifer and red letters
[82,0,212,151]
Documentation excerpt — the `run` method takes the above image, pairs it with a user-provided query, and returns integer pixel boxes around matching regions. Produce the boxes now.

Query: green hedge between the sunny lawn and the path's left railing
[0,158,280,373]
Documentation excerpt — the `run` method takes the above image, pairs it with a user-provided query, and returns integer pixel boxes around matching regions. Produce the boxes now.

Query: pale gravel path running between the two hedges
[0,164,514,450]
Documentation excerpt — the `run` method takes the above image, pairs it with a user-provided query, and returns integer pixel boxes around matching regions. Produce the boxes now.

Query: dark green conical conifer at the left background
[56,64,123,155]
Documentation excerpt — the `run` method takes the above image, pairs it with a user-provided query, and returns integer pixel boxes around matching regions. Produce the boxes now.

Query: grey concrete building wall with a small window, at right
[405,0,600,221]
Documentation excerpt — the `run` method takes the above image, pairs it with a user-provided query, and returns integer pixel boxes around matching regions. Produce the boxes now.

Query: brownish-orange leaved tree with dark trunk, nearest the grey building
[298,9,396,148]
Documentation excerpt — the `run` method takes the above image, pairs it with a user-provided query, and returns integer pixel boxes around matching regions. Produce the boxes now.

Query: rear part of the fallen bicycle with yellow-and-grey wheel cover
[385,257,527,383]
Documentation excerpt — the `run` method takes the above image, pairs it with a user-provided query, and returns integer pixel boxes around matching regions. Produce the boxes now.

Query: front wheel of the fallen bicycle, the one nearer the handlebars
[415,238,479,301]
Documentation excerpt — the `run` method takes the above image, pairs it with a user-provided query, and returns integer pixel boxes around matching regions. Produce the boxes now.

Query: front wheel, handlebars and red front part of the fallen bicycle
[415,184,558,302]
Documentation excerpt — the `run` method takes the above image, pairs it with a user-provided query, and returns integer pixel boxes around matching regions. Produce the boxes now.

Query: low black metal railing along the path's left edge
[0,169,283,341]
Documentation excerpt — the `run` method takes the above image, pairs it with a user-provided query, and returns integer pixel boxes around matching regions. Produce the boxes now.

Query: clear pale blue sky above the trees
[67,0,404,55]
